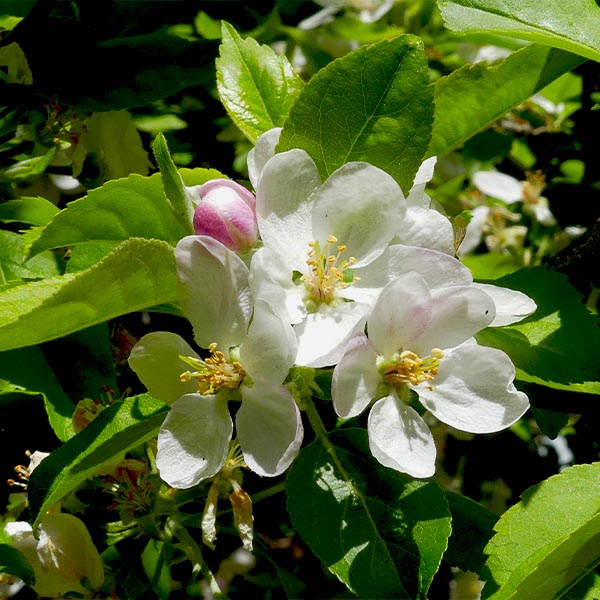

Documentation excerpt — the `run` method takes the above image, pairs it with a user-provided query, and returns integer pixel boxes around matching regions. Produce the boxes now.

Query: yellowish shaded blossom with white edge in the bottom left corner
[4,513,104,598]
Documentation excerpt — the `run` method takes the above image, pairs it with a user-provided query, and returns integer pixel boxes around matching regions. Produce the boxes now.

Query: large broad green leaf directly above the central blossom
[277,35,434,193]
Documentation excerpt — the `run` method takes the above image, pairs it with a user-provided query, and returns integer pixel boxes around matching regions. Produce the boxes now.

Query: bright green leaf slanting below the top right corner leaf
[427,45,584,156]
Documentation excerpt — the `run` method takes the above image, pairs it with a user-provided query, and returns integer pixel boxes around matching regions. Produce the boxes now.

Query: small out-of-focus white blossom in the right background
[473,171,556,226]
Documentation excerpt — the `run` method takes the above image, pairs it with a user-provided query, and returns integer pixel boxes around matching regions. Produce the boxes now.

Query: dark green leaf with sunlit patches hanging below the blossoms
[287,429,450,600]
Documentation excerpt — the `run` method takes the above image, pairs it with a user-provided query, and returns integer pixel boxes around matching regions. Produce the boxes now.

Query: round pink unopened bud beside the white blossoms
[194,179,258,252]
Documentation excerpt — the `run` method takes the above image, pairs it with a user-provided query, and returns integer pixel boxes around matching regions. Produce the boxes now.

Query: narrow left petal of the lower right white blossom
[331,333,381,418]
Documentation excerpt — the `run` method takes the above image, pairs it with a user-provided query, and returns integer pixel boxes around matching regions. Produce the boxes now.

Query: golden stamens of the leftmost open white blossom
[179,343,246,396]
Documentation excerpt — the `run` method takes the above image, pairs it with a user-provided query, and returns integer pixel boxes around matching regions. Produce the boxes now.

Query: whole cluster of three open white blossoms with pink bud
[129,129,536,488]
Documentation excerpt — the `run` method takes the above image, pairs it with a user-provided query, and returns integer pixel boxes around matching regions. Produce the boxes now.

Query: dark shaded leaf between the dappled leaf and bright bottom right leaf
[444,492,498,573]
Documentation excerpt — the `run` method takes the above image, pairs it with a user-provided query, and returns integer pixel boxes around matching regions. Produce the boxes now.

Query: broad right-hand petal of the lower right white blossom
[417,341,529,433]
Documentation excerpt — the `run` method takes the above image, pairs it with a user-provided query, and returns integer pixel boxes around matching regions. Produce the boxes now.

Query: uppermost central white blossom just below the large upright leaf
[249,133,406,367]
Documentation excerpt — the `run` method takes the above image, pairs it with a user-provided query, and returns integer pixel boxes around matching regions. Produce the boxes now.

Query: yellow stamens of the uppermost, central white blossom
[301,235,360,304]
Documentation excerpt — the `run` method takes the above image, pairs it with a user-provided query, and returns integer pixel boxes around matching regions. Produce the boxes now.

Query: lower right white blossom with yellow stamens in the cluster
[331,272,529,477]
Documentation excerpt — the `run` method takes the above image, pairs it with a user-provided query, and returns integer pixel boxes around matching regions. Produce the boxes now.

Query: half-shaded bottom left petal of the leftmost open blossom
[156,394,233,489]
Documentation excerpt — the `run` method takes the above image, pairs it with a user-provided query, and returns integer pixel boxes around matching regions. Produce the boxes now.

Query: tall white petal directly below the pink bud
[175,235,252,350]
